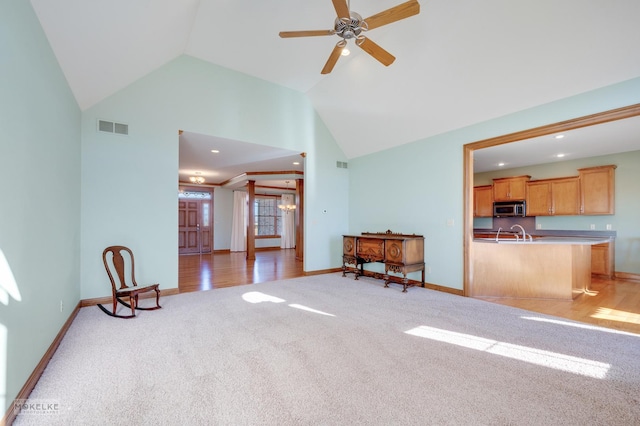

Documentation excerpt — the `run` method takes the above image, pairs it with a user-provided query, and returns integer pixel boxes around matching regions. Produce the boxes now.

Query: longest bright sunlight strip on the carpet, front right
[405,325,611,379]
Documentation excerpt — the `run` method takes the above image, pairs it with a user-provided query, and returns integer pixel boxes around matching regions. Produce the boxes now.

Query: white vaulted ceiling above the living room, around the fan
[31,0,640,185]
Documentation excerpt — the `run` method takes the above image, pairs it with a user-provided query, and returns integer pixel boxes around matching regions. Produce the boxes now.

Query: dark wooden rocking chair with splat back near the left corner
[98,246,161,318]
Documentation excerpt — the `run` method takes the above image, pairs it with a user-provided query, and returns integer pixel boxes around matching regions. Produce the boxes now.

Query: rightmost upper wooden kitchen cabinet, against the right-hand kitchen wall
[578,165,616,215]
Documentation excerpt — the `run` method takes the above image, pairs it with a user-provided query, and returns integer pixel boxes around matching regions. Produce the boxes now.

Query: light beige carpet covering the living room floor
[15,273,640,425]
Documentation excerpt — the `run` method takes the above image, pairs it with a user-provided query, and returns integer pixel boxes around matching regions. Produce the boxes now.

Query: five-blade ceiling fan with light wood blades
[280,0,420,74]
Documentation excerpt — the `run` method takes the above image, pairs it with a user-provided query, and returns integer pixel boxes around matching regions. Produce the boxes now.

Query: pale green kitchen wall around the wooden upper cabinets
[474,151,640,274]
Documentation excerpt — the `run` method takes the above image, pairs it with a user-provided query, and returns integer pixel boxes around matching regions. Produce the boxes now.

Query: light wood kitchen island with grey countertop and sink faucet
[469,237,609,300]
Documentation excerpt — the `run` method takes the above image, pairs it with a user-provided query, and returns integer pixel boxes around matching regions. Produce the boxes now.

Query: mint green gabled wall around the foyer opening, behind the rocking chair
[81,56,348,299]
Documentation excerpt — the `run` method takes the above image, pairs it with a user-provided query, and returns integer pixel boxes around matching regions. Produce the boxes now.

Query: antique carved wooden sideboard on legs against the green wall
[342,231,424,293]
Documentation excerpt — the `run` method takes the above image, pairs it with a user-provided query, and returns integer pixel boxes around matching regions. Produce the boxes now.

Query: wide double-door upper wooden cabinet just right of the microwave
[526,177,580,216]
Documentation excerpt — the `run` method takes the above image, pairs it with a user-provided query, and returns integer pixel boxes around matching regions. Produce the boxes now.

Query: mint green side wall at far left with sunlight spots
[0,1,80,414]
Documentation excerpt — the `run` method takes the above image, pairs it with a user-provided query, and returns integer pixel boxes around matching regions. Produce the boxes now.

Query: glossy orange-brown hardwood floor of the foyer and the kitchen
[178,249,640,334]
